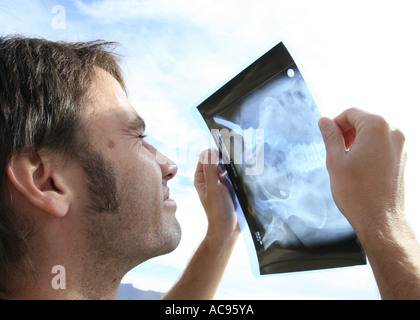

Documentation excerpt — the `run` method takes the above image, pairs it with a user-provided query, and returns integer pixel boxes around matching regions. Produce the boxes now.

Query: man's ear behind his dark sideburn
[6,152,70,218]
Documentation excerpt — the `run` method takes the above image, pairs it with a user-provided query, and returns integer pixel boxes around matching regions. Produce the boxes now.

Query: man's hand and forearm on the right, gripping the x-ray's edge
[319,109,420,299]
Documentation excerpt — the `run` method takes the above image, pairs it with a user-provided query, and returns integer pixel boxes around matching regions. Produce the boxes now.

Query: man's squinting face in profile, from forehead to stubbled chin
[81,69,181,268]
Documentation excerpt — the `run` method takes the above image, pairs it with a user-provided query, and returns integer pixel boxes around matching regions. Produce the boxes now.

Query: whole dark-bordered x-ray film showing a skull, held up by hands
[197,43,366,275]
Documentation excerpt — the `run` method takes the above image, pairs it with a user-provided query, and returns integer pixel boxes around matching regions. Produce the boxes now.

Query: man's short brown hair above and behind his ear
[0,36,125,293]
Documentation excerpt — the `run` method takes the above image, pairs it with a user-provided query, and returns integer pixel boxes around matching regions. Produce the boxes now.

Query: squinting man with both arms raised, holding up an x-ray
[0,38,420,299]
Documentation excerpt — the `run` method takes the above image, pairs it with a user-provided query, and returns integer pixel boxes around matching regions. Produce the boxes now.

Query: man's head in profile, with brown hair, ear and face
[0,37,180,298]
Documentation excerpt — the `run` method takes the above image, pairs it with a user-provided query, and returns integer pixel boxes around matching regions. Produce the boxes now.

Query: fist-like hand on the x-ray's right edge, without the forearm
[319,109,406,235]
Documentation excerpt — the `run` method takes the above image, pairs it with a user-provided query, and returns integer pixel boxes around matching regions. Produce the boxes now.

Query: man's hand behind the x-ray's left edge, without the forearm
[194,150,240,238]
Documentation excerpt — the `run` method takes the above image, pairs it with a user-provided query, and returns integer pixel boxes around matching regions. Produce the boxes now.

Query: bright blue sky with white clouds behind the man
[0,0,420,299]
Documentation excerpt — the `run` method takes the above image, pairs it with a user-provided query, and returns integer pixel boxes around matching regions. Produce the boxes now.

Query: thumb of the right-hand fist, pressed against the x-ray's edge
[318,117,346,162]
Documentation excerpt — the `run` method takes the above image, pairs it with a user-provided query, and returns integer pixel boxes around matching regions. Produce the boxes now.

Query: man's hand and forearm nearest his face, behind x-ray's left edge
[164,150,240,300]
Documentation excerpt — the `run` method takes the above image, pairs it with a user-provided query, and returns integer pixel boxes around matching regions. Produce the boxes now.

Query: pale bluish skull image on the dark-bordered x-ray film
[223,72,352,249]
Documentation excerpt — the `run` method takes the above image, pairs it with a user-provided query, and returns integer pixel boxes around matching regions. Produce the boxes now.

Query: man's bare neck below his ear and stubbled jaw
[3,205,138,300]
